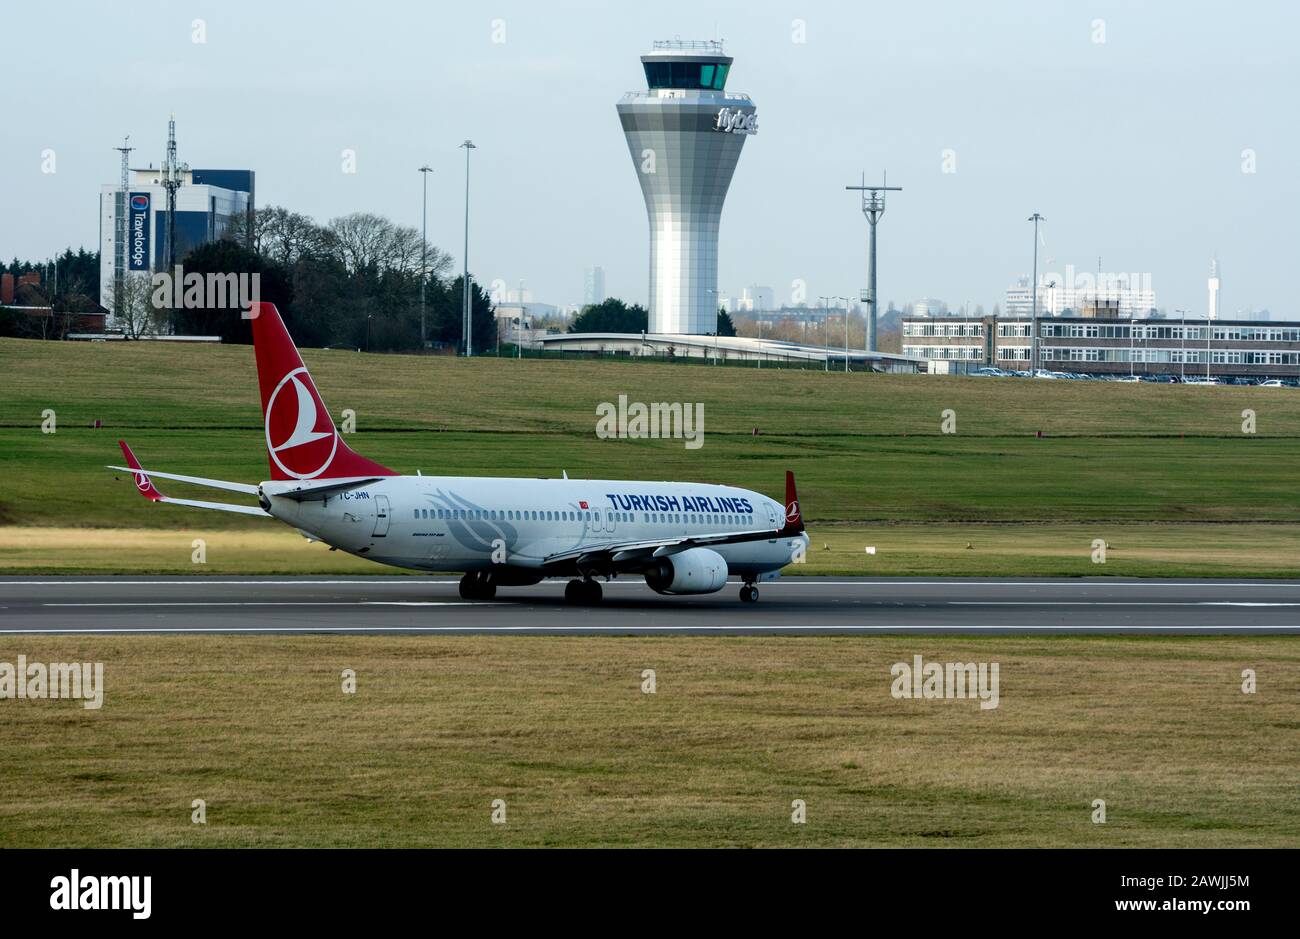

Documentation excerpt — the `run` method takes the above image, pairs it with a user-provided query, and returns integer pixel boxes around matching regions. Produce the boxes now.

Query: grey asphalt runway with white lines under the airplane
[0,576,1300,636]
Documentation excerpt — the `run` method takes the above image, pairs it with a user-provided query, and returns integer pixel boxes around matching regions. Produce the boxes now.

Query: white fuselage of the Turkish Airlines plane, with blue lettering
[261,476,807,577]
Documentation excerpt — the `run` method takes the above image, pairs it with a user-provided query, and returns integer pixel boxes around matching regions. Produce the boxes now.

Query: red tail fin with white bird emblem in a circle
[251,303,397,480]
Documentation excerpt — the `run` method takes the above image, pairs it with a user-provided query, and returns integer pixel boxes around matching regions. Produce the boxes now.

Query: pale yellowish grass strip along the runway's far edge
[0,520,1300,577]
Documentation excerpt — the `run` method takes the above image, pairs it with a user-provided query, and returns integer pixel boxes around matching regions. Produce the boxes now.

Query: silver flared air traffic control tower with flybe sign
[618,40,758,336]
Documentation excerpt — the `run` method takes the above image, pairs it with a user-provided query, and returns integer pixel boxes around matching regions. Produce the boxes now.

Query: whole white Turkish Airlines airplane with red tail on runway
[108,303,809,605]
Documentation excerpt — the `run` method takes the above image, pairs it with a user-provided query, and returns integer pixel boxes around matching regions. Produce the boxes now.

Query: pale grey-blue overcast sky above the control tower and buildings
[0,0,1300,317]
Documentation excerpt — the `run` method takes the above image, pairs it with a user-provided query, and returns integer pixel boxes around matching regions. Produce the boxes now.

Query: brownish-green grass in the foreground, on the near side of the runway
[0,636,1300,847]
